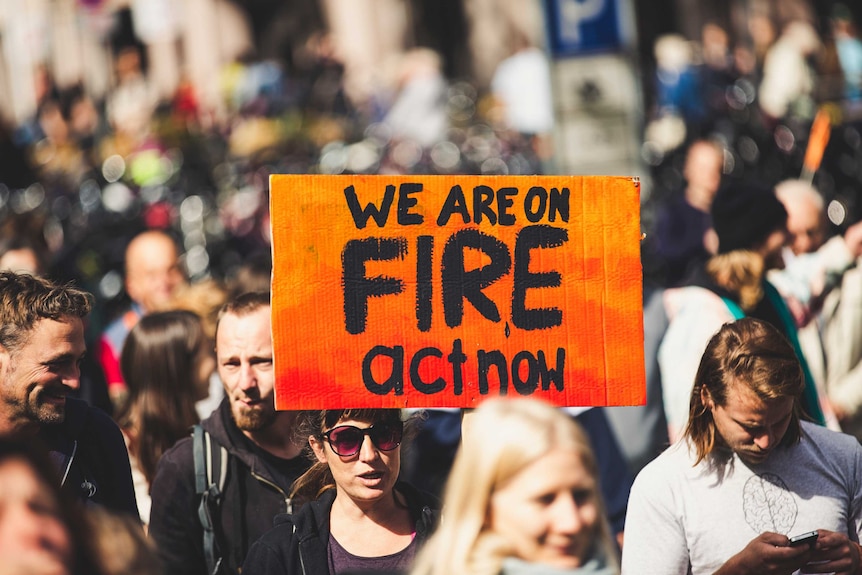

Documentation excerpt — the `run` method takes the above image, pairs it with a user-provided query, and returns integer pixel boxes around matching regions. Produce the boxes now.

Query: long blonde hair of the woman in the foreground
[411,398,616,575]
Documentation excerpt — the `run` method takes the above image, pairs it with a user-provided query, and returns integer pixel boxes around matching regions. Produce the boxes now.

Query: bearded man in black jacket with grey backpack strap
[149,293,310,575]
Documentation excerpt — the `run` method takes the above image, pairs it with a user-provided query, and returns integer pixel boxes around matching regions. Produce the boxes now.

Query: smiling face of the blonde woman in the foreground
[489,449,600,569]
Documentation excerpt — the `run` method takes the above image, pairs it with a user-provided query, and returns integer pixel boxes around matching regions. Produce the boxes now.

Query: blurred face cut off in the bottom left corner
[0,458,72,575]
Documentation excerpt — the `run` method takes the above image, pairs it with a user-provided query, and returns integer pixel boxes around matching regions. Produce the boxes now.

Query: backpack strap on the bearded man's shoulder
[192,425,228,575]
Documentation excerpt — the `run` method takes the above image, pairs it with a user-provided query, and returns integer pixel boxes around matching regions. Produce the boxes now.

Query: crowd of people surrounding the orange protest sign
[0,1,862,575]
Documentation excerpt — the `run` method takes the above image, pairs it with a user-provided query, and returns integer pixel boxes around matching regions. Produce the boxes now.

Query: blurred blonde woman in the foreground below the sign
[411,398,619,575]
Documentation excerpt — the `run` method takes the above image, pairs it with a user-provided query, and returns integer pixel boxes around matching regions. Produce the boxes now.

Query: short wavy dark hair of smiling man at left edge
[0,272,93,350]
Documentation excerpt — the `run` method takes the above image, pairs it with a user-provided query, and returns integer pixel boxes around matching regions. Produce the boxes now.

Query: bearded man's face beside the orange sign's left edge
[216,306,276,435]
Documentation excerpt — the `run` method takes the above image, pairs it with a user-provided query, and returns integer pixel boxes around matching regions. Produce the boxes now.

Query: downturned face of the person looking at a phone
[701,383,793,464]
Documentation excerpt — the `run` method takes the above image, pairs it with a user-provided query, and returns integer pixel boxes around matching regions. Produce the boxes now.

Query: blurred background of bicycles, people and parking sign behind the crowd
[0,0,862,320]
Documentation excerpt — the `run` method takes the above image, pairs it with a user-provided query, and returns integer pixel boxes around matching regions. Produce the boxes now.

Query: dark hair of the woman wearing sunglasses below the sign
[290,408,413,502]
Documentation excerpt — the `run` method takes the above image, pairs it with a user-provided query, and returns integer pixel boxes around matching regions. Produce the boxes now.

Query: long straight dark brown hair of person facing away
[117,310,206,483]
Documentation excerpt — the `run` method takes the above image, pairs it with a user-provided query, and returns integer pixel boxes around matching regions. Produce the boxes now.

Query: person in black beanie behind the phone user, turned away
[658,181,840,441]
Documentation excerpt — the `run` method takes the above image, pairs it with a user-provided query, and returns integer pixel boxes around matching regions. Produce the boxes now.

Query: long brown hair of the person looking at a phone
[684,318,805,465]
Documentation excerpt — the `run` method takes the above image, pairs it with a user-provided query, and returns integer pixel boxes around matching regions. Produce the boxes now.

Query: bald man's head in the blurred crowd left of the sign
[126,230,185,312]
